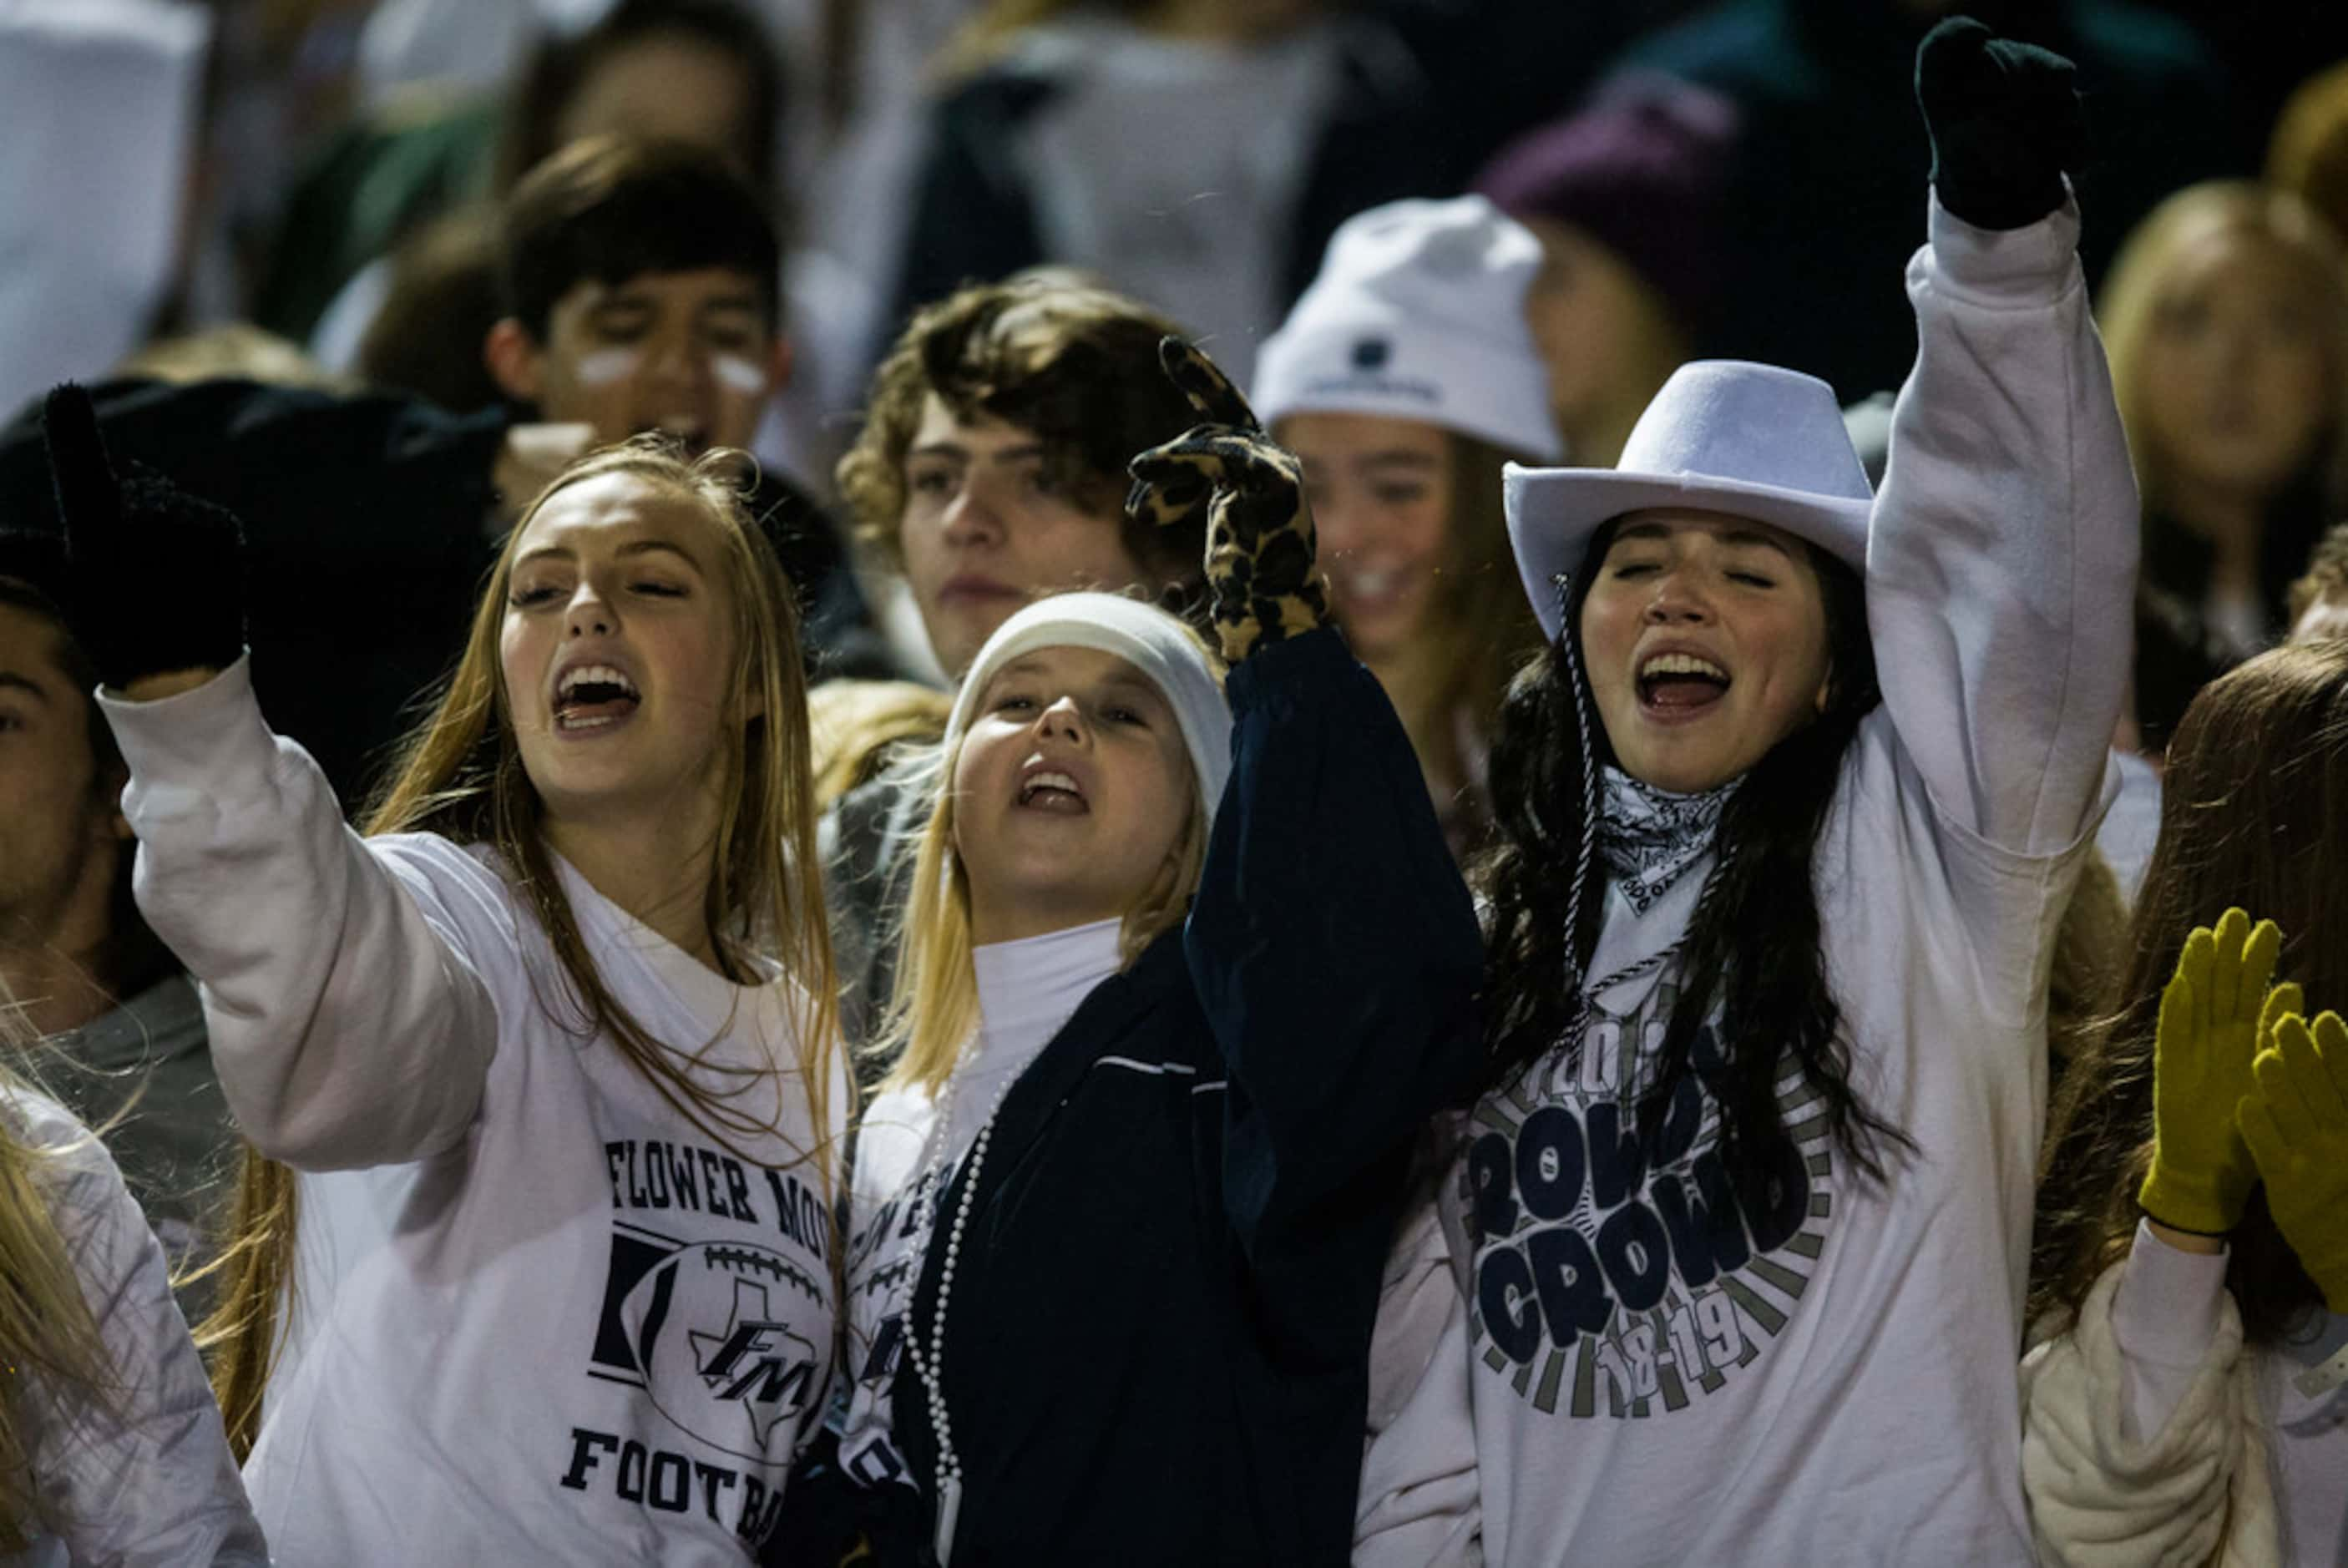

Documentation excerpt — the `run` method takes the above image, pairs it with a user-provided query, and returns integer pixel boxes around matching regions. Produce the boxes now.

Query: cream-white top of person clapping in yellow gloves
[2022,1226,2348,1568]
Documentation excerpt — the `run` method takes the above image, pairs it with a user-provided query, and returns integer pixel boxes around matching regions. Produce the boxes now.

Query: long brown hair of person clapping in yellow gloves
[2029,641,2348,1345]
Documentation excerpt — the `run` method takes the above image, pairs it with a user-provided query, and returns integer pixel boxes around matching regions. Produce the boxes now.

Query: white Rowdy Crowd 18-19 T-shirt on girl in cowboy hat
[1451,716,2076,1568]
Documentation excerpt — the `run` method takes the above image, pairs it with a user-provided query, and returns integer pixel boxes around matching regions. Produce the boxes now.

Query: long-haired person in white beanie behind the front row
[1252,195,1564,852]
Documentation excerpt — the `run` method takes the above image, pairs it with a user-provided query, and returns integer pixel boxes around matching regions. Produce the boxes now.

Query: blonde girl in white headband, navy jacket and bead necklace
[822,534,1480,1563]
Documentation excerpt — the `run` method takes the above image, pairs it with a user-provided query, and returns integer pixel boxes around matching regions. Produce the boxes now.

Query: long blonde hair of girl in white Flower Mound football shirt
[200,437,838,1455]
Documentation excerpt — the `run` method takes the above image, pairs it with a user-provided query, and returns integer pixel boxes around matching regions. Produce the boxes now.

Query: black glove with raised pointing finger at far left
[43,382,244,690]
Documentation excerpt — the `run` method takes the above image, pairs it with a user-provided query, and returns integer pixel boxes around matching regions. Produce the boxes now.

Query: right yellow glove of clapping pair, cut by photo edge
[2238,1012,2348,1313]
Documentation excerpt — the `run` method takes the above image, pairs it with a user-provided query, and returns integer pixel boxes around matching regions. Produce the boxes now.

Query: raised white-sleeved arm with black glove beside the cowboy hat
[1867,21,2137,854]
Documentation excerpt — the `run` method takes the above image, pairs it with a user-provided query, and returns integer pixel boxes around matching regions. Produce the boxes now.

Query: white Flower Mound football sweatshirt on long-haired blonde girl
[104,660,848,1565]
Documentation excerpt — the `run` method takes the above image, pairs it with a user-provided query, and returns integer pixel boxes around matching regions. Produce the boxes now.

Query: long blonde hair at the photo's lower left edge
[0,986,122,1554]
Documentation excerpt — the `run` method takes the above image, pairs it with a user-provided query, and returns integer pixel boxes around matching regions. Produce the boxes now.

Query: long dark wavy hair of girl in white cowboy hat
[1477,524,1906,1192]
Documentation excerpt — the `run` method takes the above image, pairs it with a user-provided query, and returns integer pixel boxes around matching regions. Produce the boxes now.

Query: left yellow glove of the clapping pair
[2137,908,2301,1235]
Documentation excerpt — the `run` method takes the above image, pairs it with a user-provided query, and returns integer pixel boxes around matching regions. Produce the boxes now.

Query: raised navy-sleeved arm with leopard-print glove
[1134,341,1484,1267]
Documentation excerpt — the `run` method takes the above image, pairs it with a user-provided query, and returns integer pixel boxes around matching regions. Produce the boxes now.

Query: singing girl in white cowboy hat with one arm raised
[1323,21,2134,1568]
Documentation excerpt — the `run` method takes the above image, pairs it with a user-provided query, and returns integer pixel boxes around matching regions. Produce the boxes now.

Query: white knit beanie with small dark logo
[1249,195,1564,463]
